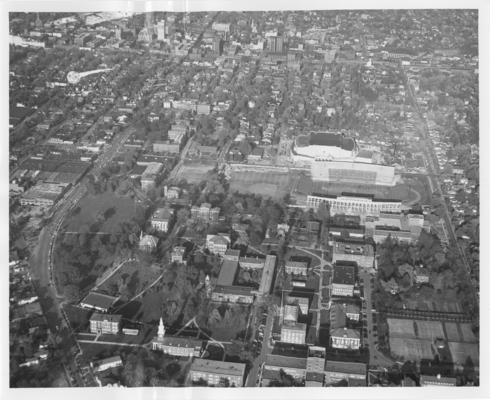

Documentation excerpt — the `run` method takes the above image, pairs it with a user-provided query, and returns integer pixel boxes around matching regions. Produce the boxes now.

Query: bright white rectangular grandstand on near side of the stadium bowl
[311,160,397,186]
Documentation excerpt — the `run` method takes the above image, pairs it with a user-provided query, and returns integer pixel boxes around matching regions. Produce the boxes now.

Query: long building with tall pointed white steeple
[151,318,203,357]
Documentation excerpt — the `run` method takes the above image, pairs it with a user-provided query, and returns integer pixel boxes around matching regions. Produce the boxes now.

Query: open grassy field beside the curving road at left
[64,191,140,232]
